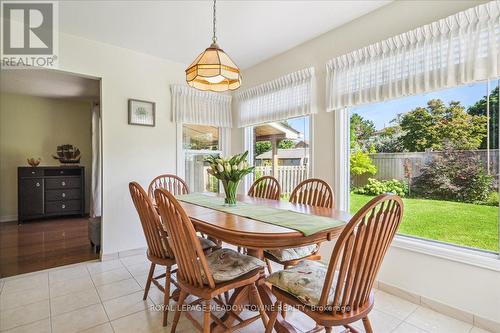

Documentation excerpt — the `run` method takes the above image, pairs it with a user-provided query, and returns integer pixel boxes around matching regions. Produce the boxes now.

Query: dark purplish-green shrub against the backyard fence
[412,150,493,203]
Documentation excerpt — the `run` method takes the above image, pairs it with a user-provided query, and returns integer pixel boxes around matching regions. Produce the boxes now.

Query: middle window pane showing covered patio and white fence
[251,116,311,198]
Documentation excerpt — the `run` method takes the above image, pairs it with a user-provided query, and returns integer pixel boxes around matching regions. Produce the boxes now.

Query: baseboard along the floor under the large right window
[376,281,500,333]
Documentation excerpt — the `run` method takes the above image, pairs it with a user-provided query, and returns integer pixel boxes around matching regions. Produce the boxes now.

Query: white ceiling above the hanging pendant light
[59,0,391,69]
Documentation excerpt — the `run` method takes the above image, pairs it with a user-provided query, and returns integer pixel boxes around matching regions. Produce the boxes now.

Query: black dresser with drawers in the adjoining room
[17,166,85,223]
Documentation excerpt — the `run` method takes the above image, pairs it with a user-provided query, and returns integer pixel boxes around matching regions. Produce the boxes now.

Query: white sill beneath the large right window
[392,235,500,272]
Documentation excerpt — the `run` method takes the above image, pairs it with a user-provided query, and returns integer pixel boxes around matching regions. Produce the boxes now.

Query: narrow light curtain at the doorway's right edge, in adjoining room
[90,104,102,218]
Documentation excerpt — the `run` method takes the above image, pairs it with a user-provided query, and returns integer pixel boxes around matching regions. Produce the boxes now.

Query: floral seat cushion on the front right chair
[267,260,336,305]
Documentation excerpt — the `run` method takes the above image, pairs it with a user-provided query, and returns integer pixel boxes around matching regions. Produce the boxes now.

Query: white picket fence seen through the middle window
[255,165,309,195]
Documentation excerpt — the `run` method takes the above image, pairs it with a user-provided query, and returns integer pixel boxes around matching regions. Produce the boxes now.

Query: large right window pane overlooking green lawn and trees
[350,80,499,253]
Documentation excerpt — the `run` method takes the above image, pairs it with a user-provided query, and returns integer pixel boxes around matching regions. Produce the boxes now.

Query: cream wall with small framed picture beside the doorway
[55,34,185,254]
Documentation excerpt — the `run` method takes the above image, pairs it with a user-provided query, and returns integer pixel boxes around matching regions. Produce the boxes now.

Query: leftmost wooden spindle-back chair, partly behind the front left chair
[129,182,176,326]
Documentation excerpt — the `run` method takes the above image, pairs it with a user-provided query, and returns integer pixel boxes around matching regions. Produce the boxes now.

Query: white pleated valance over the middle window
[235,67,315,127]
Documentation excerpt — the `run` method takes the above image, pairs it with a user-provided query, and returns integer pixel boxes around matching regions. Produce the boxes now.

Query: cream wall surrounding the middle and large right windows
[232,1,500,322]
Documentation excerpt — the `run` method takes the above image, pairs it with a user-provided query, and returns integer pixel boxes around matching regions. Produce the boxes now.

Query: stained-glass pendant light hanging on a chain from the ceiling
[186,0,241,91]
